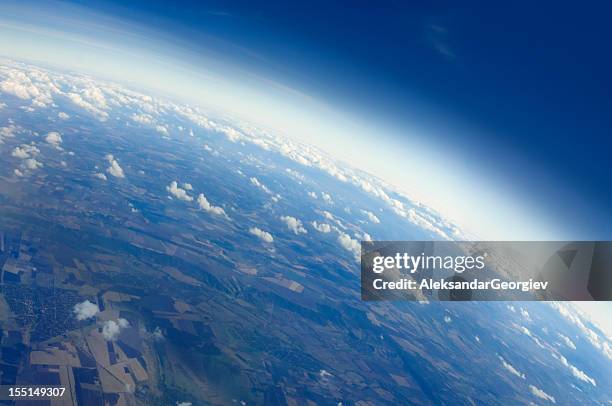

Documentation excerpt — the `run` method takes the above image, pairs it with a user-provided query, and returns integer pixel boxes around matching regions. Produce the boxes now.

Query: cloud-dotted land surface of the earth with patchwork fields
[0,60,612,405]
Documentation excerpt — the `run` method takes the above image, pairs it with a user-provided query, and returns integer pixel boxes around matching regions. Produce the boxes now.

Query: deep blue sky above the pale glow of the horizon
[70,1,612,238]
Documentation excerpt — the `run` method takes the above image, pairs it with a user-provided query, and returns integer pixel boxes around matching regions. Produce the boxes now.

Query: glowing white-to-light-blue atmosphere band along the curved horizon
[0,2,609,240]
